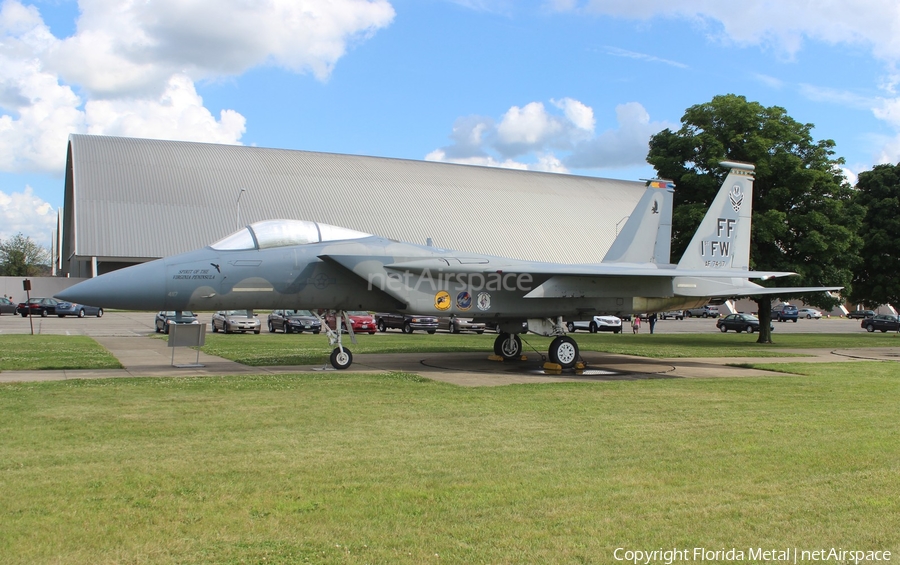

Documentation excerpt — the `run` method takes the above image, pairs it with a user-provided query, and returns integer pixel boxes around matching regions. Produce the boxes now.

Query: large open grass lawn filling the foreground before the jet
[0,360,900,564]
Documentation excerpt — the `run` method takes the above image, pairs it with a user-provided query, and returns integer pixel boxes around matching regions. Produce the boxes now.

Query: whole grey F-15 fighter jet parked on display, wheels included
[57,162,840,369]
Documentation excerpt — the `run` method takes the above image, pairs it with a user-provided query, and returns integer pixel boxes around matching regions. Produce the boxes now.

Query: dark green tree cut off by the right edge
[850,164,900,308]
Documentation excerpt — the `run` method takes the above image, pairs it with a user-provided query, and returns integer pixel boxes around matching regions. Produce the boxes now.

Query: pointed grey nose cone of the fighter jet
[56,261,167,310]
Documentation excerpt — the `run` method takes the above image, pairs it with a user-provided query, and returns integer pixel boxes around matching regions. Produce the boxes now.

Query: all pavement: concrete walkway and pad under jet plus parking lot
[0,312,900,386]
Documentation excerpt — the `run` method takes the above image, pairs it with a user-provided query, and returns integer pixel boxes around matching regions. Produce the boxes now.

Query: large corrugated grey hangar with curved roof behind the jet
[57,135,645,277]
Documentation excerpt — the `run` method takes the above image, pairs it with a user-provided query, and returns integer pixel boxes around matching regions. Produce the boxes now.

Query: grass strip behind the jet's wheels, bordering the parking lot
[195,332,900,367]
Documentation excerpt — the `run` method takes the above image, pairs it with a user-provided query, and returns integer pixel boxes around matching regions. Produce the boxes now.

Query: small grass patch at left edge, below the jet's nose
[0,334,122,371]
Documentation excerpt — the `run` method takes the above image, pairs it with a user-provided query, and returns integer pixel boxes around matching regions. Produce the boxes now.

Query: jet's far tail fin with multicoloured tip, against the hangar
[603,180,675,265]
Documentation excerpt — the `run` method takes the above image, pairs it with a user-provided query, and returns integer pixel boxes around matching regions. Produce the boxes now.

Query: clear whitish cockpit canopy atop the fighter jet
[210,220,371,251]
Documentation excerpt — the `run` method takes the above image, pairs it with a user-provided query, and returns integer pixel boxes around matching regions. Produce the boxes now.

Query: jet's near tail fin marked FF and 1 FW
[678,161,754,271]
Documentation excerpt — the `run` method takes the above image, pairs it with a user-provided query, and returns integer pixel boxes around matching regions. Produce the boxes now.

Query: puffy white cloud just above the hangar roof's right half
[425,98,664,172]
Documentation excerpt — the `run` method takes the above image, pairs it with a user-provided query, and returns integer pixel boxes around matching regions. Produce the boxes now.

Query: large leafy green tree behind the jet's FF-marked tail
[647,94,864,343]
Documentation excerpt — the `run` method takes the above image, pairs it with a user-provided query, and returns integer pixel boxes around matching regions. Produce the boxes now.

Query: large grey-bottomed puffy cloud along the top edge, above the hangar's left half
[47,0,394,96]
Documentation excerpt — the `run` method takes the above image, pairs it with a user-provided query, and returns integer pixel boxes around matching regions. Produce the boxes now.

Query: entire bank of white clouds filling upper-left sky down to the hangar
[0,0,394,174]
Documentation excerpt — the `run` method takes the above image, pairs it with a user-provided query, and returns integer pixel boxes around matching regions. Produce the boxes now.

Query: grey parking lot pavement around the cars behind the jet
[0,312,865,334]
